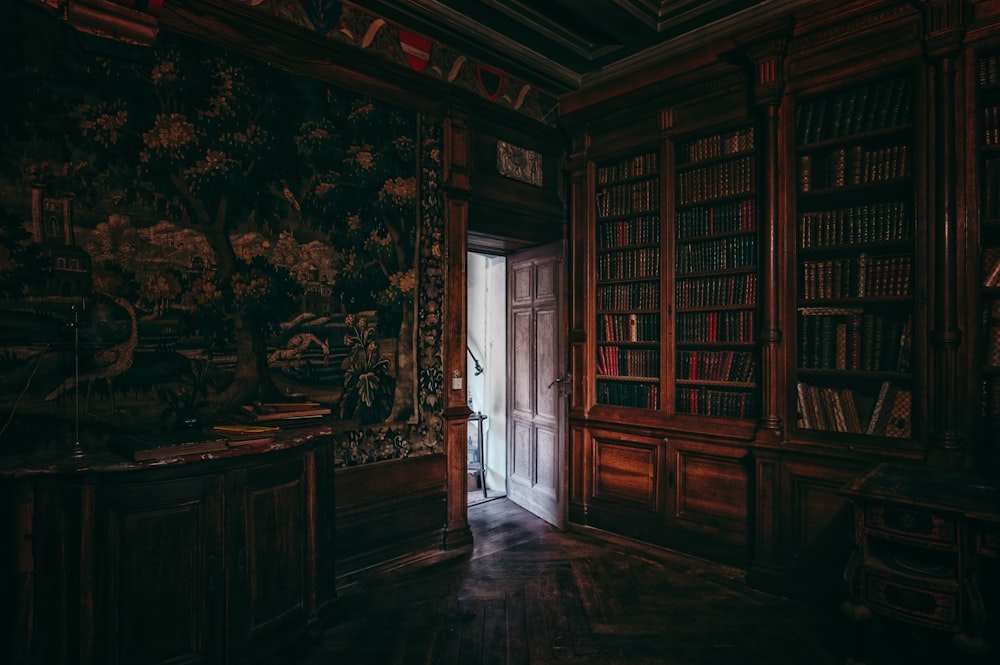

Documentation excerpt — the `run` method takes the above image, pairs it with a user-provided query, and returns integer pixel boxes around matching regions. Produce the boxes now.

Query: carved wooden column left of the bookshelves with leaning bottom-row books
[748,36,788,441]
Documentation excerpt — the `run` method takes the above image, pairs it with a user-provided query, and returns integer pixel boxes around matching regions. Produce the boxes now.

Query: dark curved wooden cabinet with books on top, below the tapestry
[0,437,336,665]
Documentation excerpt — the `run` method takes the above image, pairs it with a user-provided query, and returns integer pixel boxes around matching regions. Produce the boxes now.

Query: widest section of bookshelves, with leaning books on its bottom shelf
[791,76,917,439]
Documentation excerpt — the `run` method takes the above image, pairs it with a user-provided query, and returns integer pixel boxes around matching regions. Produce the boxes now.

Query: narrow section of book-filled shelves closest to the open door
[594,150,663,410]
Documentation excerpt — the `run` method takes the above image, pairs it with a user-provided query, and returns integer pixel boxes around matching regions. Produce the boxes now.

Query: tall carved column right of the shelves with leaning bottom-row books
[916,0,965,466]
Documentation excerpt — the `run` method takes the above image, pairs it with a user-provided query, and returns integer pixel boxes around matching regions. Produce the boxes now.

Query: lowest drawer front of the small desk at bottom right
[865,570,961,629]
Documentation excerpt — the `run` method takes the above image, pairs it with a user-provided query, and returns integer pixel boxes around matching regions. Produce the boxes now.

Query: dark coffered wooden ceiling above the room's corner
[355,0,814,95]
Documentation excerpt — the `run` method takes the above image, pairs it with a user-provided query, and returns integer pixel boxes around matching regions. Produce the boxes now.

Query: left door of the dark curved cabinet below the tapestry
[95,477,224,665]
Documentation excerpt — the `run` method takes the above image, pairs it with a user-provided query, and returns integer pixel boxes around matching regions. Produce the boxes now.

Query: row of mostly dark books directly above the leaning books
[798,307,913,372]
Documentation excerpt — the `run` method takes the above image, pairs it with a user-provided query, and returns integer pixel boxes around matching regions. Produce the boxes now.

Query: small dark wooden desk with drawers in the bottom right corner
[845,464,1000,652]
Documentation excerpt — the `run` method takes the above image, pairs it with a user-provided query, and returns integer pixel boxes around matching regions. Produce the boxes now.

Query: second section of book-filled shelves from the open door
[674,127,759,418]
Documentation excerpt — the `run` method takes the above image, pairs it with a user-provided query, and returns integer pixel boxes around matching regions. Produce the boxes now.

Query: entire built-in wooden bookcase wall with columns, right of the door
[560,0,1000,596]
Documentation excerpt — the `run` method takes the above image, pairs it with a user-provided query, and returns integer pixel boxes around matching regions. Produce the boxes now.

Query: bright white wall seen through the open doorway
[466,253,507,490]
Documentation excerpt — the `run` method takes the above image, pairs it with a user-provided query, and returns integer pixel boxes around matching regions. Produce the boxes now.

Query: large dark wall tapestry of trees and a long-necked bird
[0,10,443,465]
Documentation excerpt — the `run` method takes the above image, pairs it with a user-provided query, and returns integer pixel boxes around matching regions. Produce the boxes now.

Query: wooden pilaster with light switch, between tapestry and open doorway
[442,113,472,549]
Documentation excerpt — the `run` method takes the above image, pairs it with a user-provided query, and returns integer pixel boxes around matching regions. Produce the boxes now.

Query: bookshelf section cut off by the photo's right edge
[976,51,1000,458]
